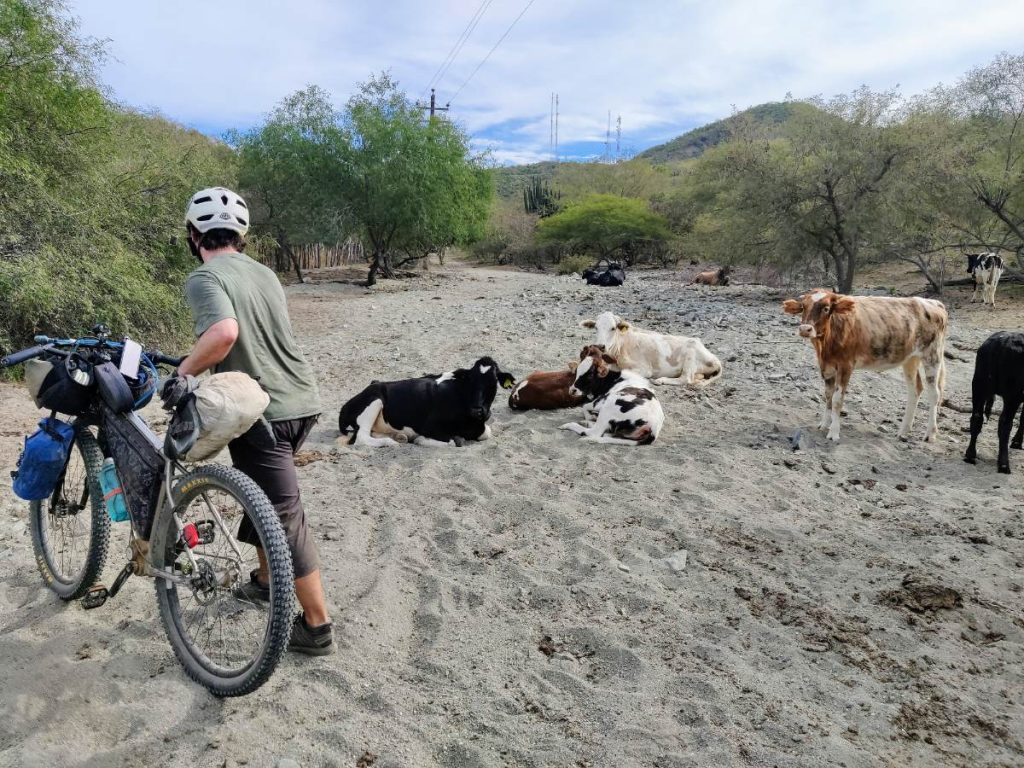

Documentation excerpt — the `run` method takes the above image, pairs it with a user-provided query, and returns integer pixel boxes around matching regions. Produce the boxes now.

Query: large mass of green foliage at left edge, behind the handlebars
[0,0,233,348]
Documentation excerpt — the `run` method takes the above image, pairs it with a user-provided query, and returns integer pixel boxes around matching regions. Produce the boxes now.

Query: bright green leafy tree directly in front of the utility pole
[338,74,493,286]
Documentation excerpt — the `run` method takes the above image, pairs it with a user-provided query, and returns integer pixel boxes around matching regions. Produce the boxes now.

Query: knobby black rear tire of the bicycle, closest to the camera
[152,464,295,696]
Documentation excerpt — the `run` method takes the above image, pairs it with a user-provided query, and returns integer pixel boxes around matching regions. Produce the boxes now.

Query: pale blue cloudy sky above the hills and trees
[69,0,1024,163]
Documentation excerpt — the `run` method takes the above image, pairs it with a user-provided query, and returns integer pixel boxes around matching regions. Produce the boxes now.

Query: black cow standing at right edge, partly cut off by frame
[964,331,1024,474]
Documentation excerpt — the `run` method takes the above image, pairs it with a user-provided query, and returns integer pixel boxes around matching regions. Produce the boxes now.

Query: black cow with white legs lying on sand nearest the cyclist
[338,357,515,446]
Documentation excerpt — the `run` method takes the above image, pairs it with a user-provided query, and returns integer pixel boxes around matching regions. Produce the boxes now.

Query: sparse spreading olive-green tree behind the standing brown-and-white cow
[696,88,901,292]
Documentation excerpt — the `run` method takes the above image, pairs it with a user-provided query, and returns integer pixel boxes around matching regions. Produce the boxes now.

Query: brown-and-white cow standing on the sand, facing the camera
[782,289,948,441]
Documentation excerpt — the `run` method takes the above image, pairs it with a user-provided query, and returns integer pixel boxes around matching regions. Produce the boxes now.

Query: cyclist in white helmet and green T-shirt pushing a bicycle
[172,186,335,655]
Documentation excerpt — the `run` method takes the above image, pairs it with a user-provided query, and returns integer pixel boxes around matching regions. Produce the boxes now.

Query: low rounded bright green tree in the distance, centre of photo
[537,195,672,262]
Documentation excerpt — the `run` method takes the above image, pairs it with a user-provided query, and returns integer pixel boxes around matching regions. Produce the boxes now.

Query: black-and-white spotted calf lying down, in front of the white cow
[560,344,665,445]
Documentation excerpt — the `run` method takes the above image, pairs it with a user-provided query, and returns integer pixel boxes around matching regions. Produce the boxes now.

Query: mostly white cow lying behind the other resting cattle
[581,312,722,385]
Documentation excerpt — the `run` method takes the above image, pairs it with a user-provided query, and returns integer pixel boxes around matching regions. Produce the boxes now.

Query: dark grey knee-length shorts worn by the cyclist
[227,416,319,579]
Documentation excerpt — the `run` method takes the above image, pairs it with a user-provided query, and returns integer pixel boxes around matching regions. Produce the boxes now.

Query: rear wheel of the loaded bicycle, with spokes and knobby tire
[152,465,295,696]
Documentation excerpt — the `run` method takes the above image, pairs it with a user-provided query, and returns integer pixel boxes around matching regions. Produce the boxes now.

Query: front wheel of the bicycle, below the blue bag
[29,428,111,600]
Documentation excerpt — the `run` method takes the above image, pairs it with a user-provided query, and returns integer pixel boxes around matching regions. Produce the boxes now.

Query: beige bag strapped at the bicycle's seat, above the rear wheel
[164,371,270,462]
